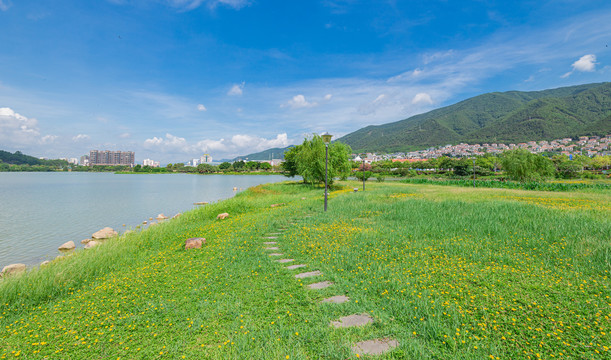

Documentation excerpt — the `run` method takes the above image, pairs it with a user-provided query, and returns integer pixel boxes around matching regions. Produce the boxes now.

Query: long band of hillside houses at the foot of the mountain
[354,135,611,164]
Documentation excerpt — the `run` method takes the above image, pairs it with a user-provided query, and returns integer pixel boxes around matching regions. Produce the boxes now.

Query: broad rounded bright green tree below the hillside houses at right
[501,149,555,181]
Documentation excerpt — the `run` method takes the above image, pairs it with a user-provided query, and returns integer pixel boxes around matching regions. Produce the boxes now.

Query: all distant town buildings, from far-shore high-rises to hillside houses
[49,135,611,168]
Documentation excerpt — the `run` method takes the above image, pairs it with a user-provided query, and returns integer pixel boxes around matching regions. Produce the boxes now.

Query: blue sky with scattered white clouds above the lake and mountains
[0,0,611,163]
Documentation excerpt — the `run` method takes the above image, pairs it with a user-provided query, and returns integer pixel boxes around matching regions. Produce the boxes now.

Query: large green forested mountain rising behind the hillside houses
[338,82,611,152]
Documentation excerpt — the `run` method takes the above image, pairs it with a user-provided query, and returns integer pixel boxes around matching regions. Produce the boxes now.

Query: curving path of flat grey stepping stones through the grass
[263,215,399,355]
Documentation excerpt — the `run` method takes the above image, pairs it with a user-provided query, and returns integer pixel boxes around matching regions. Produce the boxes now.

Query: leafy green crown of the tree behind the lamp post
[282,135,352,184]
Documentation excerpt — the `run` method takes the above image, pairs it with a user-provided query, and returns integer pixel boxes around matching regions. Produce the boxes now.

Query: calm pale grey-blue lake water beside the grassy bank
[0,172,287,269]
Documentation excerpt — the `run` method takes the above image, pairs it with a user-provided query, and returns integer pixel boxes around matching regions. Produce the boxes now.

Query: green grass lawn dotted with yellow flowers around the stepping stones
[0,182,611,359]
